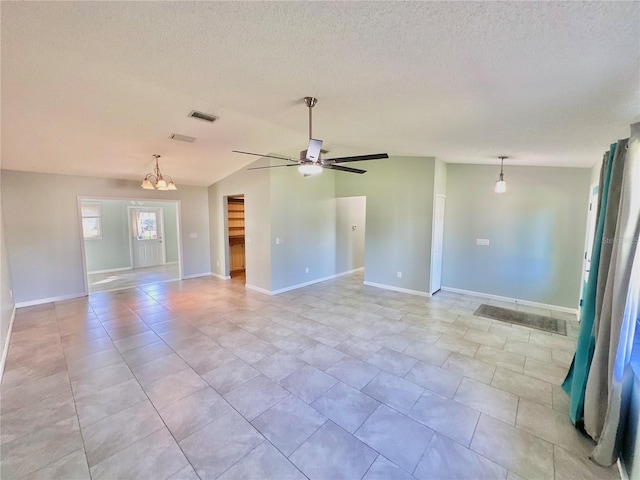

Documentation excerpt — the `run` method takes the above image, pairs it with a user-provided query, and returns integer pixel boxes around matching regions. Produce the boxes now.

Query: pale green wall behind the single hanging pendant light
[442,164,591,308]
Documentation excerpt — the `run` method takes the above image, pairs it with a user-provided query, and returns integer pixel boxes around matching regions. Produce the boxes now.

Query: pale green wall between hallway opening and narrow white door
[336,157,435,293]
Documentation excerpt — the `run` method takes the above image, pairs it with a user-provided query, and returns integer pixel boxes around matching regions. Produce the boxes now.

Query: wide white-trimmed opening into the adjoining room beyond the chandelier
[78,198,182,294]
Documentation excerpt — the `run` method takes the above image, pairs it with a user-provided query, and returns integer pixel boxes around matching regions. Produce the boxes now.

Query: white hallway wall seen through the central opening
[336,197,367,273]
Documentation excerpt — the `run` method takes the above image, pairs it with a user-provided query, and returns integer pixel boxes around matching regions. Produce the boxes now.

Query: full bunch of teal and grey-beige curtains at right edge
[562,123,640,465]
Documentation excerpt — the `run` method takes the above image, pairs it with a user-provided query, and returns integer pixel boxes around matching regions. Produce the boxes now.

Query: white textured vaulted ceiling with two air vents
[1,1,640,186]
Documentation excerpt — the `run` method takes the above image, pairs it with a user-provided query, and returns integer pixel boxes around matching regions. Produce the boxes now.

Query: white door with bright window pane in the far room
[129,208,166,268]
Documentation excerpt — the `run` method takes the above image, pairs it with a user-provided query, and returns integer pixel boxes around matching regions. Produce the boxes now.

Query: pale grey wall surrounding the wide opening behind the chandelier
[2,170,211,303]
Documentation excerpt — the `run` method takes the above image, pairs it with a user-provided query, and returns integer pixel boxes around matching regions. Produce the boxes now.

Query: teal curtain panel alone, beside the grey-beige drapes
[562,143,616,426]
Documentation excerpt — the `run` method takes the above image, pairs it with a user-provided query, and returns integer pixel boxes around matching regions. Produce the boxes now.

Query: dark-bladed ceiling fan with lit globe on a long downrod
[233,97,389,176]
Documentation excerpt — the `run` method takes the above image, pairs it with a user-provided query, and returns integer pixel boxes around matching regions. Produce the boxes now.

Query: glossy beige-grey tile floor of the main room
[0,274,619,480]
